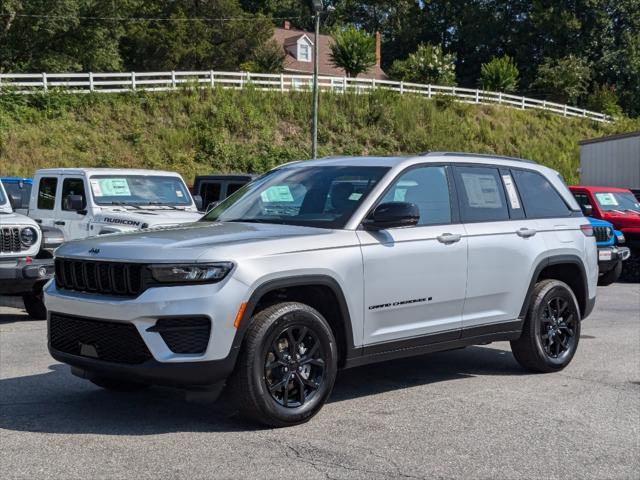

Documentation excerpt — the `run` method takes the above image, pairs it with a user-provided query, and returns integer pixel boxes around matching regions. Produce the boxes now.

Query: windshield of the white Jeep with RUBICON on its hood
[89,175,191,207]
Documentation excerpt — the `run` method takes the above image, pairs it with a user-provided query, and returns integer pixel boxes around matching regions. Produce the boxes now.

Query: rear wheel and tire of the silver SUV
[511,280,581,373]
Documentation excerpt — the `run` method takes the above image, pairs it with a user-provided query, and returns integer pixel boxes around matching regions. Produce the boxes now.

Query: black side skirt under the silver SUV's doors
[344,320,524,368]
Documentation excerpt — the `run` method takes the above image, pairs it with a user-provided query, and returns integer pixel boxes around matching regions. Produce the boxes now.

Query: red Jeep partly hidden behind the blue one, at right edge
[569,185,640,281]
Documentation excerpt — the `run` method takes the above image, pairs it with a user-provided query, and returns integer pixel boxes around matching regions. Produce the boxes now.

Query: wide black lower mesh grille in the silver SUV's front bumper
[49,313,152,365]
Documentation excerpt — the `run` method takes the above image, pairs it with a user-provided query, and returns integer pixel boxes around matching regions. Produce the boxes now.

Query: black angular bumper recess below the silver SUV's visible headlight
[148,317,211,354]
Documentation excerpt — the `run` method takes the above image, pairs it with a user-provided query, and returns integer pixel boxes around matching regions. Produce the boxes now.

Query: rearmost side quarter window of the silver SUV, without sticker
[512,170,572,218]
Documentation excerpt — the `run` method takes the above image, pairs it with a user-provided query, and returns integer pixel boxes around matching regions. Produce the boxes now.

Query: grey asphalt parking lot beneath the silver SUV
[0,284,640,480]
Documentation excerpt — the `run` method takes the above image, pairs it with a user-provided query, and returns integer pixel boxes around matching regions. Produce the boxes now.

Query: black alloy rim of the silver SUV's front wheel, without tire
[264,324,326,408]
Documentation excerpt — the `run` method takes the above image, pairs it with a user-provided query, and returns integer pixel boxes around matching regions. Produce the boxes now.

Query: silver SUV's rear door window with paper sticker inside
[455,167,509,223]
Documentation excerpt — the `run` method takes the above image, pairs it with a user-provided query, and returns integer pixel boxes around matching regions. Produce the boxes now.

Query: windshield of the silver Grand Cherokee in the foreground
[202,166,389,228]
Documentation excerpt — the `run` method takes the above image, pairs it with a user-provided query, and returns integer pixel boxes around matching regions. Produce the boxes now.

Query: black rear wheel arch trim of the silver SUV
[519,254,593,320]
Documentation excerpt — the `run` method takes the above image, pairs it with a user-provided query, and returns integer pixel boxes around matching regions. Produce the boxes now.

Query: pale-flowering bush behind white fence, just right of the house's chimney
[390,43,456,85]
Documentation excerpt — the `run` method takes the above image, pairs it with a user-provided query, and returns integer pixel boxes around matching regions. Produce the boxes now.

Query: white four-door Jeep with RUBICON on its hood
[28,168,202,241]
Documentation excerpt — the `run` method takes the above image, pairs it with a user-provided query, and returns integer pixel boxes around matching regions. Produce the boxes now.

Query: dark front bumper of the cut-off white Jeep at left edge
[0,258,55,295]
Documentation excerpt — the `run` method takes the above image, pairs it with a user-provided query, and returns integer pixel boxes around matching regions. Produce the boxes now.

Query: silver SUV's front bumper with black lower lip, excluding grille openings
[45,278,248,387]
